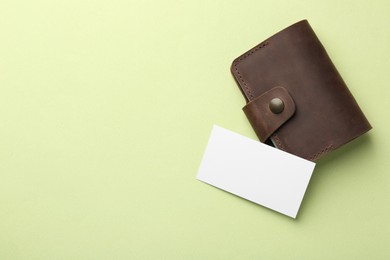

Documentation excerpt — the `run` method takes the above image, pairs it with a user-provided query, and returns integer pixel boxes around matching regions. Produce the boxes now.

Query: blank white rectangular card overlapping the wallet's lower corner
[197,125,315,218]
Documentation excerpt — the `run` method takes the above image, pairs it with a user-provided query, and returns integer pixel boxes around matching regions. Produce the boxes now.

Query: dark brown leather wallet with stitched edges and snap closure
[231,20,371,161]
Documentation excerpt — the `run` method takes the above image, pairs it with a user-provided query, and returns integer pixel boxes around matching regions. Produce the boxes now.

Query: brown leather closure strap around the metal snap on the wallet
[242,87,295,143]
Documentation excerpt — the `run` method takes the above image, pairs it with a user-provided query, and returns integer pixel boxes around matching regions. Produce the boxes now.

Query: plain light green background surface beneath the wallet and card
[0,0,390,260]
